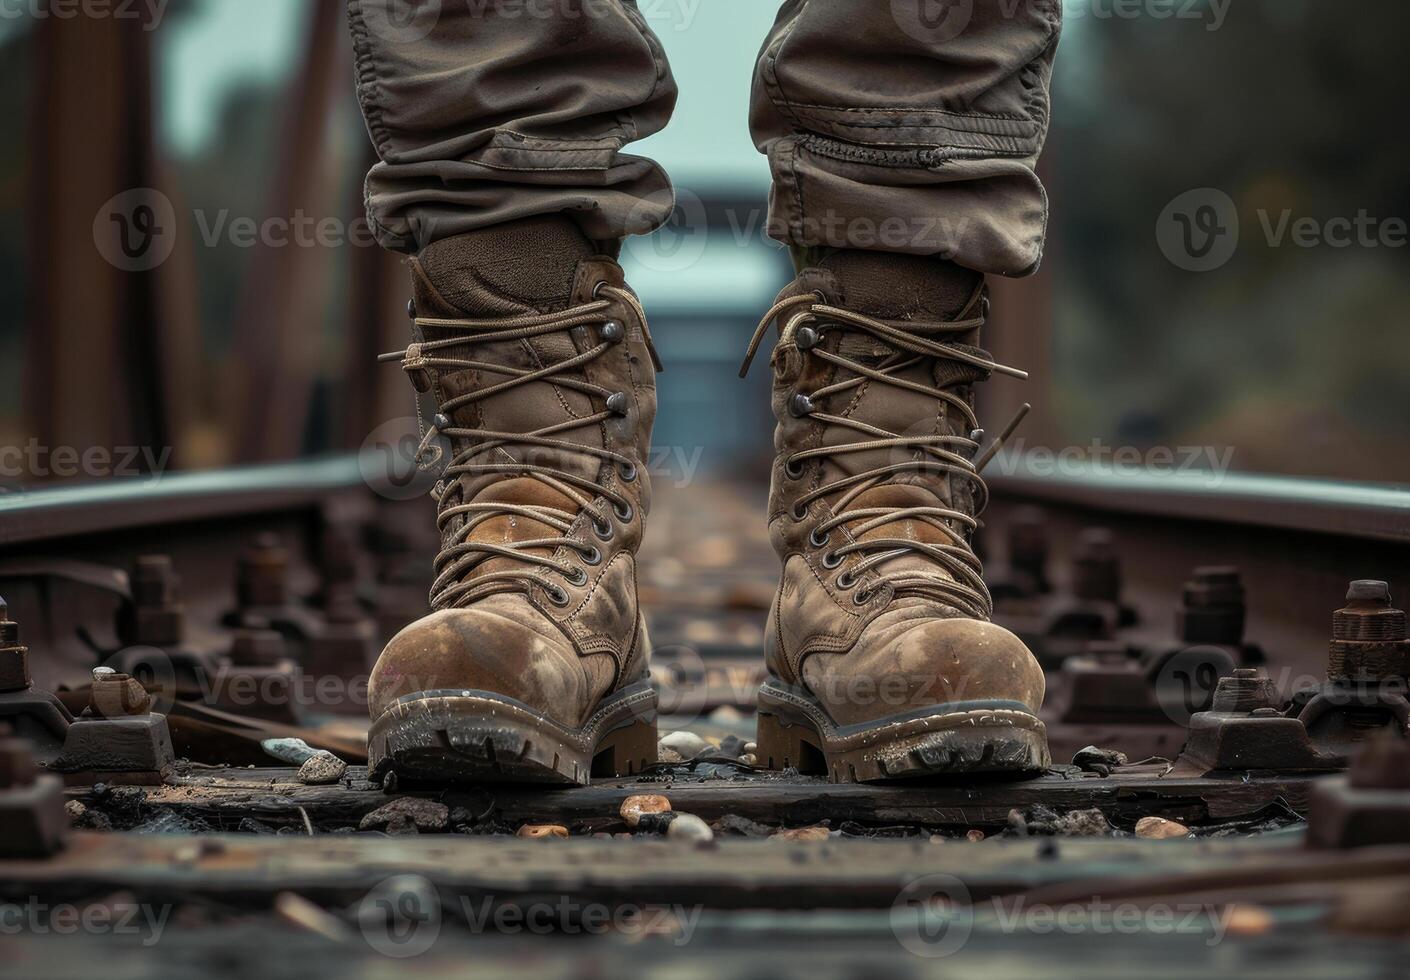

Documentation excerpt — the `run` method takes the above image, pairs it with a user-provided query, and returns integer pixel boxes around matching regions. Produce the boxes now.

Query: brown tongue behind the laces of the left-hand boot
[413,216,602,595]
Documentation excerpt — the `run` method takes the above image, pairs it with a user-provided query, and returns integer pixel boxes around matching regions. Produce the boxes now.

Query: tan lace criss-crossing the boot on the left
[378,282,660,609]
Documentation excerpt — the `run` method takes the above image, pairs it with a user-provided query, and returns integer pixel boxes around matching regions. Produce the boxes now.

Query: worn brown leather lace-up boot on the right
[744,251,1049,783]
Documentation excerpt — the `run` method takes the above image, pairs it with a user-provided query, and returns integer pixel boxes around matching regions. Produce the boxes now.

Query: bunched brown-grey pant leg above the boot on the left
[348,0,675,251]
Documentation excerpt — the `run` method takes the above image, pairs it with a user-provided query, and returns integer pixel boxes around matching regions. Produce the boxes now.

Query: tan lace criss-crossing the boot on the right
[739,289,1031,619]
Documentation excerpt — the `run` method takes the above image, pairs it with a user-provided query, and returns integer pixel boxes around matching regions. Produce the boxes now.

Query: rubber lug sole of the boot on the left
[368,681,657,785]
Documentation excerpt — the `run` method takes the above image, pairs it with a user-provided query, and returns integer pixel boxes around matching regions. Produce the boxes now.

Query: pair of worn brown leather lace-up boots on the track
[369,216,1048,784]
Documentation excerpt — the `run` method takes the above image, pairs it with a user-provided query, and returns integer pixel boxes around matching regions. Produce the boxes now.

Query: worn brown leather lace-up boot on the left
[368,216,658,784]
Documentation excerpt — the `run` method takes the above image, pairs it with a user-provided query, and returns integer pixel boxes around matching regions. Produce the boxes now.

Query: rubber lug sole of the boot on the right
[757,681,1052,783]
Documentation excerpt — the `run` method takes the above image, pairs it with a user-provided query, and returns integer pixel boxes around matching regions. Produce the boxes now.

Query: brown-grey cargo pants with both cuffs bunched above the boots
[348,0,1062,276]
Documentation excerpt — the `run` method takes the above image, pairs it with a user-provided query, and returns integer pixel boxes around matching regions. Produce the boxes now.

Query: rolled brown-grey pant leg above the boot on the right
[750,0,1062,275]
